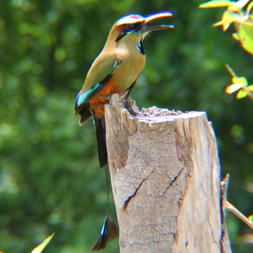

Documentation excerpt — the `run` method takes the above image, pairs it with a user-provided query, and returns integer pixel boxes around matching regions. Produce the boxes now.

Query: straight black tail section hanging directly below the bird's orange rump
[94,116,108,167]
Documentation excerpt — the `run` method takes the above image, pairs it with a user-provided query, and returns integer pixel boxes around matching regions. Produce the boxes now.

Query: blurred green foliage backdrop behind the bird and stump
[0,0,253,253]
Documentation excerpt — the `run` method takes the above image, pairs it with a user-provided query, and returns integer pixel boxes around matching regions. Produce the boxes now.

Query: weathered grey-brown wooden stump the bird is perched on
[105,96,230,253]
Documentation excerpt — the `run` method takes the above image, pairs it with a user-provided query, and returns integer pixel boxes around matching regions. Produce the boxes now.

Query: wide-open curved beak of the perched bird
[141,11,174,36]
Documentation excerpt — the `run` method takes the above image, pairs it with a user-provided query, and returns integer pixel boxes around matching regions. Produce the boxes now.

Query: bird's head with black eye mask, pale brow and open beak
[106,11,174,47]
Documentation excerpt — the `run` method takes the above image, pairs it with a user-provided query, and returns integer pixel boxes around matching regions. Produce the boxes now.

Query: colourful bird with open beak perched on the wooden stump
[75,11,174,167]
